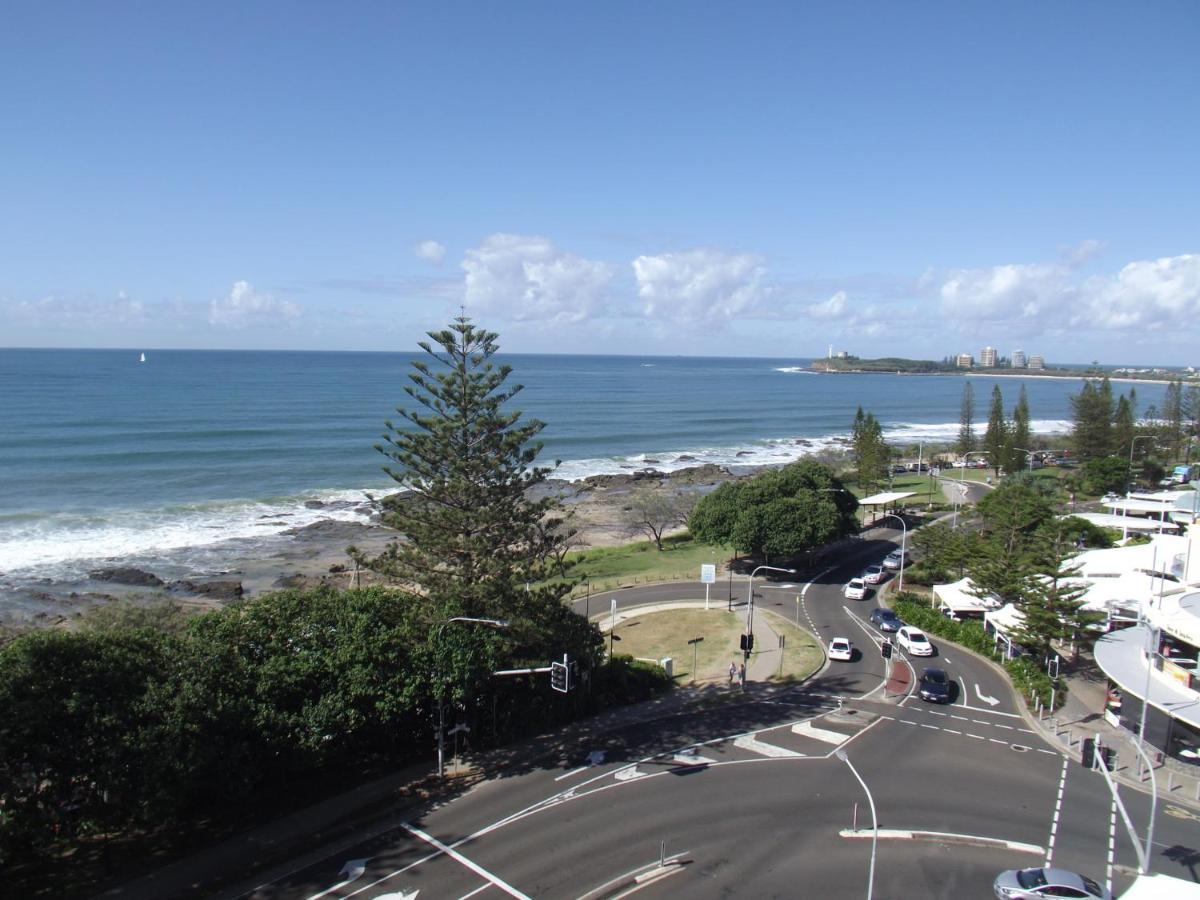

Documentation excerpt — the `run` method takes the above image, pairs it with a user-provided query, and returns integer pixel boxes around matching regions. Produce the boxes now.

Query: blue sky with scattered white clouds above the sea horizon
[0,0,1200,365]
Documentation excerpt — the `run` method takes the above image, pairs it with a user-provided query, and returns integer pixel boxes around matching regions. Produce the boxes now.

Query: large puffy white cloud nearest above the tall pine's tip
[462,234,613,323]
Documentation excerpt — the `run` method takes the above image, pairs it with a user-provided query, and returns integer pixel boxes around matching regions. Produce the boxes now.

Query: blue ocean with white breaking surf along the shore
[0,349,1163,601]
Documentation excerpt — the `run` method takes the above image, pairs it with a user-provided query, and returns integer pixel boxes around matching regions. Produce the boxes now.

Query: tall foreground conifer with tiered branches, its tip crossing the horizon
[350,317,571,618]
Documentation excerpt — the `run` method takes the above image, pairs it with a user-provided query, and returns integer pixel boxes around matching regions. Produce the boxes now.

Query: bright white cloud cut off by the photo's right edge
[1074,253,1200,330]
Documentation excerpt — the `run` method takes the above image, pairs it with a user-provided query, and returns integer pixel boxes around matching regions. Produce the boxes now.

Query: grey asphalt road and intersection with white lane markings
[230,535,1200,900]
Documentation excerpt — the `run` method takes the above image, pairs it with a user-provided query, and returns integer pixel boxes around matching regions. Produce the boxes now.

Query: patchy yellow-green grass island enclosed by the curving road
[600,607,824,684]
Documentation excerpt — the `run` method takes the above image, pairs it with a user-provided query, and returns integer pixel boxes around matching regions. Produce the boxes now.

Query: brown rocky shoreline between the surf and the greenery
[0,457,750,629]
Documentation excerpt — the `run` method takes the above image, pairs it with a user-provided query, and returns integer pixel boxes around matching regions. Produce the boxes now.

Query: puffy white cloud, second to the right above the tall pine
[634,250,767,324]
